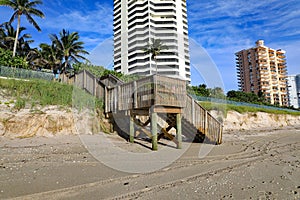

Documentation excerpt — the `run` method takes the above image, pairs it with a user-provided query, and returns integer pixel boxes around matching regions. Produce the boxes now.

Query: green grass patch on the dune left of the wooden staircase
[0,79,103,110]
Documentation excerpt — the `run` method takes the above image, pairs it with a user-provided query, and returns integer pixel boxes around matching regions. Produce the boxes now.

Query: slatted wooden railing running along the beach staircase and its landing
[62,70,223,144]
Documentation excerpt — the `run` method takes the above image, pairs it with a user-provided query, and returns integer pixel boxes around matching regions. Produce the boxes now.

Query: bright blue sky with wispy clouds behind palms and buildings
[0,0,300,91]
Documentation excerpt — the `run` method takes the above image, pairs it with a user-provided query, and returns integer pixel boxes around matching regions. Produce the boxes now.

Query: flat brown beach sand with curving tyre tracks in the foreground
[0,127,300,199]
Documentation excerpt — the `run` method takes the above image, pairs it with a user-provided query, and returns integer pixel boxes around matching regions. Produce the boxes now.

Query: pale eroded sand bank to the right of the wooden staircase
[224,111,300,132]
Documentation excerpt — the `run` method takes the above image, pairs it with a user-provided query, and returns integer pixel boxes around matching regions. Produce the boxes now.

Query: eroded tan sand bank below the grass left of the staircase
[0,106,101,138]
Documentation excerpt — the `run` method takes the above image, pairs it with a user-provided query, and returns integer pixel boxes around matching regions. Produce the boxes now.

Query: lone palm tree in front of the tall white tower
[144,38,169,74]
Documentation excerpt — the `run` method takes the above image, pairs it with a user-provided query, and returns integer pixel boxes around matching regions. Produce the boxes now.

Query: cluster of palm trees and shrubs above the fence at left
[0,0,88,72]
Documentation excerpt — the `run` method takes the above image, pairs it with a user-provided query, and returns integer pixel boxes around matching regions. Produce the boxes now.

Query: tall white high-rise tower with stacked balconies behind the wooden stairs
[114,0,191,83]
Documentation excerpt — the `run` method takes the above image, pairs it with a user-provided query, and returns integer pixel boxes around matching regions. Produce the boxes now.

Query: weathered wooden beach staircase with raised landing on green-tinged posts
[67,70,223,150]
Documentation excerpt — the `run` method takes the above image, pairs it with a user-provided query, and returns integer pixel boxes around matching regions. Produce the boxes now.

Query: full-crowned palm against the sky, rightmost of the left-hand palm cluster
[50,29,89,71]
